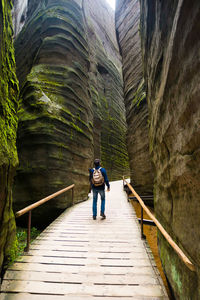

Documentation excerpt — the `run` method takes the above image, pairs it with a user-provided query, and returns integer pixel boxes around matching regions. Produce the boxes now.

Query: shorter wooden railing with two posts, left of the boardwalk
[15,184,75,252]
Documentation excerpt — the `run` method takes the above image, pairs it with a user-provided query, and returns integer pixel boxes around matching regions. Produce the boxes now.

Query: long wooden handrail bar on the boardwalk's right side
[123,177,196,272]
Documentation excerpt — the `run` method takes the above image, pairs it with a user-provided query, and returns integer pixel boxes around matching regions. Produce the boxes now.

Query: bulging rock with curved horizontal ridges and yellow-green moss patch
[14,1,93,222]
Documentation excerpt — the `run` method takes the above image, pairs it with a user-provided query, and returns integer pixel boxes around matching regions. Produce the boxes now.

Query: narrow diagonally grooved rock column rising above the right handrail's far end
[116,0,153,195]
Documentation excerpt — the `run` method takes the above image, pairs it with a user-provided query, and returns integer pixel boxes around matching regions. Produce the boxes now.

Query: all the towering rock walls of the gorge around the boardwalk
[0,0,200,300]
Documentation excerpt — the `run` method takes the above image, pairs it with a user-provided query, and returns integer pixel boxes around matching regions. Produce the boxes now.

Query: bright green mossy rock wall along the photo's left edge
[0,0,18,273]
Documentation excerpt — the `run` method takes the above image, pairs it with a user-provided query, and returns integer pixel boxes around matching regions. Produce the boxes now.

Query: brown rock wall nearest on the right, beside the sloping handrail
[141,0,200,300]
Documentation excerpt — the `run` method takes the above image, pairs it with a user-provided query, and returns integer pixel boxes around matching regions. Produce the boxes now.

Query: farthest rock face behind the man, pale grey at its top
[83,0,129,180]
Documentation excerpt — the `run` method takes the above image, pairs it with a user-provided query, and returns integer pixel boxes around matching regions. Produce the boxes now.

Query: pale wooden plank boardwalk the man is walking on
[0,181,168,300]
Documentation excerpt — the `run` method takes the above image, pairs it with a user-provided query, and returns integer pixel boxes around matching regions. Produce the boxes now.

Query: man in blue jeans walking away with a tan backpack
[89,158,110,220]
